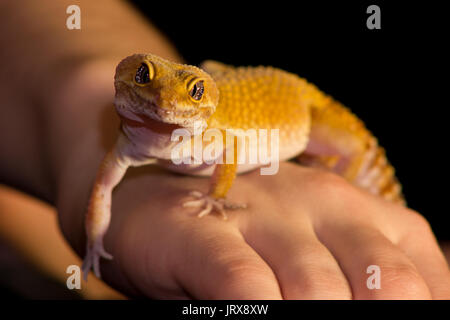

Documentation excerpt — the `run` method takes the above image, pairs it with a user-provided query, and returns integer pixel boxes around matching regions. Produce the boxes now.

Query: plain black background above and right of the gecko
[128,0,450,239]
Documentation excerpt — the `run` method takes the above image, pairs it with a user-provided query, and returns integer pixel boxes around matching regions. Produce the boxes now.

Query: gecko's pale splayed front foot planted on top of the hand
[183,191,247,220]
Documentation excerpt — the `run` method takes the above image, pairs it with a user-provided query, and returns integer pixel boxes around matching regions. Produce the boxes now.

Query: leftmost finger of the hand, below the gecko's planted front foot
[173,222,281,299]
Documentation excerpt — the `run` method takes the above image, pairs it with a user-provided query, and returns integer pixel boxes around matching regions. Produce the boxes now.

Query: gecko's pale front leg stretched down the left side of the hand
[82,144,129,280]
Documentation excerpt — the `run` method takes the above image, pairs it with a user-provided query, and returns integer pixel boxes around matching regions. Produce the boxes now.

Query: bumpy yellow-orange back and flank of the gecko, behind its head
[206,61,310,134]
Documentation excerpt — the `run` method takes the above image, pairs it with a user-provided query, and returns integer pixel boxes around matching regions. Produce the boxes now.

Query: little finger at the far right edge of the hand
[398,214,450,300]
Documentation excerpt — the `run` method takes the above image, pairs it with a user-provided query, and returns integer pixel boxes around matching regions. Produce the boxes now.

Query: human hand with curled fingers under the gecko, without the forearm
[58,163,450,299]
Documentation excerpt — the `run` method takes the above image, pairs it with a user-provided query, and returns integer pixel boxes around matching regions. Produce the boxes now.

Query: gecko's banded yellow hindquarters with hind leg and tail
[297,85,406,205]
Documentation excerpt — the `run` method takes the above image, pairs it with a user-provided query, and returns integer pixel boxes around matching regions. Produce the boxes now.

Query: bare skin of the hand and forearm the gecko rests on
[0,1,450,299]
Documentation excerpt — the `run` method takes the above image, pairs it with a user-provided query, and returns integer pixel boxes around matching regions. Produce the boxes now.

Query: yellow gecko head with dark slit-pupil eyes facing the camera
[114,54,219,128]
